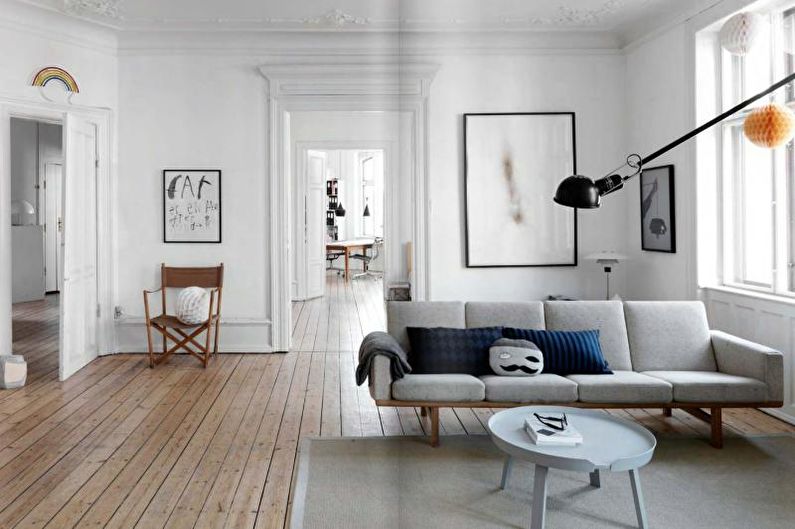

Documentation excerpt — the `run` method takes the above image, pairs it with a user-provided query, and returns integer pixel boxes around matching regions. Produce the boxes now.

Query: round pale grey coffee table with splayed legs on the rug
[488,406,657,529]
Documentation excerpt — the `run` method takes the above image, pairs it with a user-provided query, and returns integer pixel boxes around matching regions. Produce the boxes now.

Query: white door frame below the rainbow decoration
[0,94,116,380]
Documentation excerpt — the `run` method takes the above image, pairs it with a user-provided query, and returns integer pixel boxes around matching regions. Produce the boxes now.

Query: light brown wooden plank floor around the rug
[0,274,795,529]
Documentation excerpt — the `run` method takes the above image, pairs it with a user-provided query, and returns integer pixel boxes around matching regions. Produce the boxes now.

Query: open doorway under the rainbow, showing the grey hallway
[9,118,64,380]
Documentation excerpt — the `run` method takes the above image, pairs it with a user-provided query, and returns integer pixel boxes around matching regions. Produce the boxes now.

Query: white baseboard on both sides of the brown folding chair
[115,318,273,353]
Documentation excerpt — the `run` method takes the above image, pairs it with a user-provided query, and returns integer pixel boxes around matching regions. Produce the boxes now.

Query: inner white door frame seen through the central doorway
[290,140,400,298]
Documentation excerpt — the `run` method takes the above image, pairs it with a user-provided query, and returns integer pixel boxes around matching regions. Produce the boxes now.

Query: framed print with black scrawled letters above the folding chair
[163,169,221,243]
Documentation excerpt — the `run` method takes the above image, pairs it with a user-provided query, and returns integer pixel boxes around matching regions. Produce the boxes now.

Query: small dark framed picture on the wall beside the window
[640,165,676,253]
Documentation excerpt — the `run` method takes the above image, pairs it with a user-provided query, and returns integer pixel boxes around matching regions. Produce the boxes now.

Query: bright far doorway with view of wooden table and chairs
[293,148,386,301]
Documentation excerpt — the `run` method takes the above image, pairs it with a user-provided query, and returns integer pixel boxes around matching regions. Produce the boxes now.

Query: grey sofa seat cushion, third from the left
[566,371,673,404]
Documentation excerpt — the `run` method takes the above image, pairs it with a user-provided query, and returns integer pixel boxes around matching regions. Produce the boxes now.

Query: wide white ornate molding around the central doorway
[259,60,439,351]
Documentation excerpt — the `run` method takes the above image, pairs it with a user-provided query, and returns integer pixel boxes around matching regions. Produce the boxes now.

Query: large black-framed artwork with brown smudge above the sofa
[464,112,577,268]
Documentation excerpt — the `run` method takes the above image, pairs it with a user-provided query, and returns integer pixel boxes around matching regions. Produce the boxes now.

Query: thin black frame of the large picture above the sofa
[463,111,579,268]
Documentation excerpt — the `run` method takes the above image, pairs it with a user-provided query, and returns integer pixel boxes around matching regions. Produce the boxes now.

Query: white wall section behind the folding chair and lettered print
[117,54,272,351]
